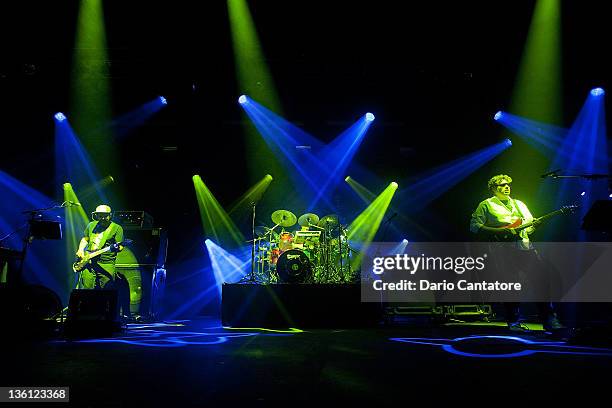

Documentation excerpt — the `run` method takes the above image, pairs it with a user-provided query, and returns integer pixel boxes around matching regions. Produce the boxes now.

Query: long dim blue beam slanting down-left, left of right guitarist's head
[396,139,512,210]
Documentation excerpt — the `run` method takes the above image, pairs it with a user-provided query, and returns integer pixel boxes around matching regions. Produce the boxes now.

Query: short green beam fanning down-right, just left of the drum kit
[192,174,245,248]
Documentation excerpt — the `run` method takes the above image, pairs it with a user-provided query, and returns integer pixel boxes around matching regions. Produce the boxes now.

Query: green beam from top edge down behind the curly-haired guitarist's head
[494,0,563,209]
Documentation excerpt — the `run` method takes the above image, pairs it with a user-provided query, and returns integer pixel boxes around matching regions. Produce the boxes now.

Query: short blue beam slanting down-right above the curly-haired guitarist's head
[495,111,567,158]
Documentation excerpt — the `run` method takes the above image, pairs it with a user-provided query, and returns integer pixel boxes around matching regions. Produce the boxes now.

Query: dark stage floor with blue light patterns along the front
[0,318,612,407]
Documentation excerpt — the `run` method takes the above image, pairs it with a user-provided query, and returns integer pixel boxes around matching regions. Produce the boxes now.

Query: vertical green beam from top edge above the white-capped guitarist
[70,0,116,174]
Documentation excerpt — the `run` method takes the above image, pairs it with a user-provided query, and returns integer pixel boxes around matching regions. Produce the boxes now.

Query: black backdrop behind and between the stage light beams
[0,0,612,316]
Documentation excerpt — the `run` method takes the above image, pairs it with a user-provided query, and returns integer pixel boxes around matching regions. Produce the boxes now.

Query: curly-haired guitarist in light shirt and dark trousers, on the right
[470,174,562,331]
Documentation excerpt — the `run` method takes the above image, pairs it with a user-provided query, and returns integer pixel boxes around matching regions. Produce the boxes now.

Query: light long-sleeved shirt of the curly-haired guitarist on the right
[470,197,533,245]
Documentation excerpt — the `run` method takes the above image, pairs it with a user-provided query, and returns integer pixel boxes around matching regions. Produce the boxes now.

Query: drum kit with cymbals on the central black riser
[251,210,355,283]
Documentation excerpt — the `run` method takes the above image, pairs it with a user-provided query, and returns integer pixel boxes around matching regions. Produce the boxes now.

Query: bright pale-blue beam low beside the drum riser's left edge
[204,239,251,296]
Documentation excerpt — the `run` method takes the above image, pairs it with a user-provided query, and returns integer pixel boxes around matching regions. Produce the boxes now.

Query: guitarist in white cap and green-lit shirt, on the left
[76,204,130,318]
